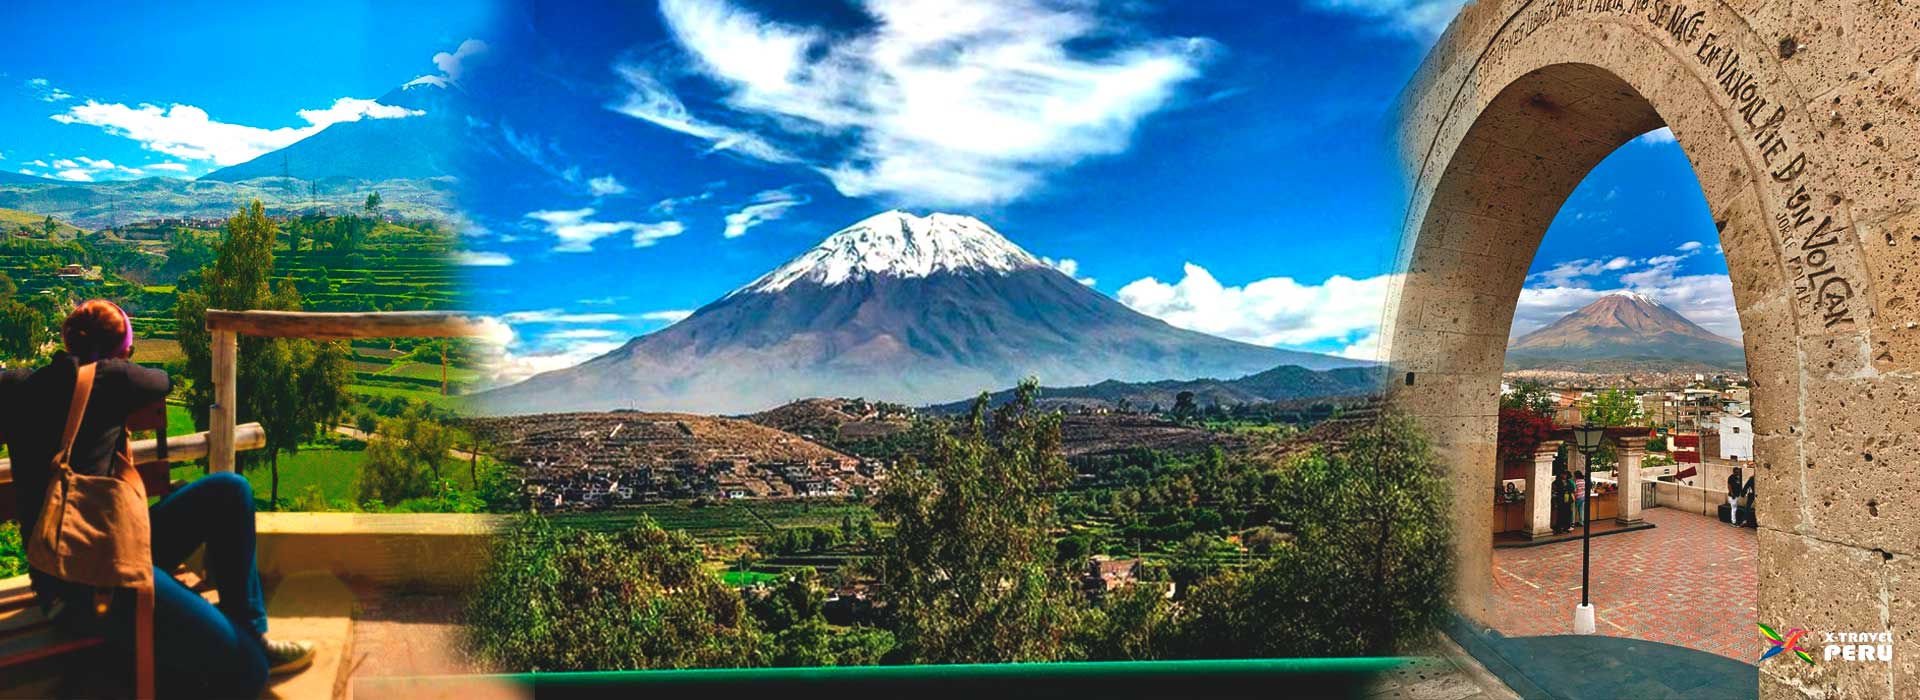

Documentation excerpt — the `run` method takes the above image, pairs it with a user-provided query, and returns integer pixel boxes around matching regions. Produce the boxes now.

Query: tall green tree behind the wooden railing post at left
[173,199,353,506]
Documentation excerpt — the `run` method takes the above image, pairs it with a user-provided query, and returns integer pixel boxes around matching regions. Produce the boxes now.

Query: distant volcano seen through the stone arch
[1507,292,1747,372]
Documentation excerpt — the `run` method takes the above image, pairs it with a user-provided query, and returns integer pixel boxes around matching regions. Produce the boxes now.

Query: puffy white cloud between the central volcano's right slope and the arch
[1117,263,1392,345]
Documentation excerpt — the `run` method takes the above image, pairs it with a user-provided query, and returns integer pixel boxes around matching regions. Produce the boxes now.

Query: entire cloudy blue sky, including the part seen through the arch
[0,0,1738,380]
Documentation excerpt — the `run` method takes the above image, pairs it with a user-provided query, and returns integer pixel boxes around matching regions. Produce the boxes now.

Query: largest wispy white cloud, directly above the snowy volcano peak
[612,0,1213,205]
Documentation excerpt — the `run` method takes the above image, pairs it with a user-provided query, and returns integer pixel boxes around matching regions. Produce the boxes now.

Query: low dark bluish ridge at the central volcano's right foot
[927,364,1384,414]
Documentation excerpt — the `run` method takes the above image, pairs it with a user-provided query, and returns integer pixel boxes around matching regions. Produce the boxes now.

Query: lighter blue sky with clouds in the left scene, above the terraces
[0,0,493,180]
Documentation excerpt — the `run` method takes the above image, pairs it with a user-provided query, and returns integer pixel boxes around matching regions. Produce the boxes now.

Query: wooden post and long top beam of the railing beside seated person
[207,309,480,472]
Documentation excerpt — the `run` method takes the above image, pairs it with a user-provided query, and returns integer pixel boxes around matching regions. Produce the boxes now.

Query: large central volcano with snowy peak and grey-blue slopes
[474,211,1367,414]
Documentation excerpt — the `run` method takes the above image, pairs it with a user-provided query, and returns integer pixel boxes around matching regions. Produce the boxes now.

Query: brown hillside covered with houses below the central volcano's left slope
[465,410,847,466]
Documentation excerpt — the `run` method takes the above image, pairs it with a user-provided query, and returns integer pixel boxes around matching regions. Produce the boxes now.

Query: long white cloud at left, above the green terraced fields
[52,98,422,165]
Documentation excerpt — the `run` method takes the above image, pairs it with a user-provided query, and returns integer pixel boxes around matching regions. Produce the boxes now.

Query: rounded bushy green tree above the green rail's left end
[467,516,772,671]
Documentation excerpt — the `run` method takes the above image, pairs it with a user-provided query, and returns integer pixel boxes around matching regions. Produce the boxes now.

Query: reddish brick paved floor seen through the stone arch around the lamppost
[1492,508,1759,664]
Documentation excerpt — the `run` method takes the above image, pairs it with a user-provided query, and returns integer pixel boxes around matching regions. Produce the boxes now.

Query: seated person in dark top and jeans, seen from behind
[0,299,313,698]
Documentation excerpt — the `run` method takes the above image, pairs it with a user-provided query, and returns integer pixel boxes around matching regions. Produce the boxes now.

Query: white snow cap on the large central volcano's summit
[733,209,1044,293]
